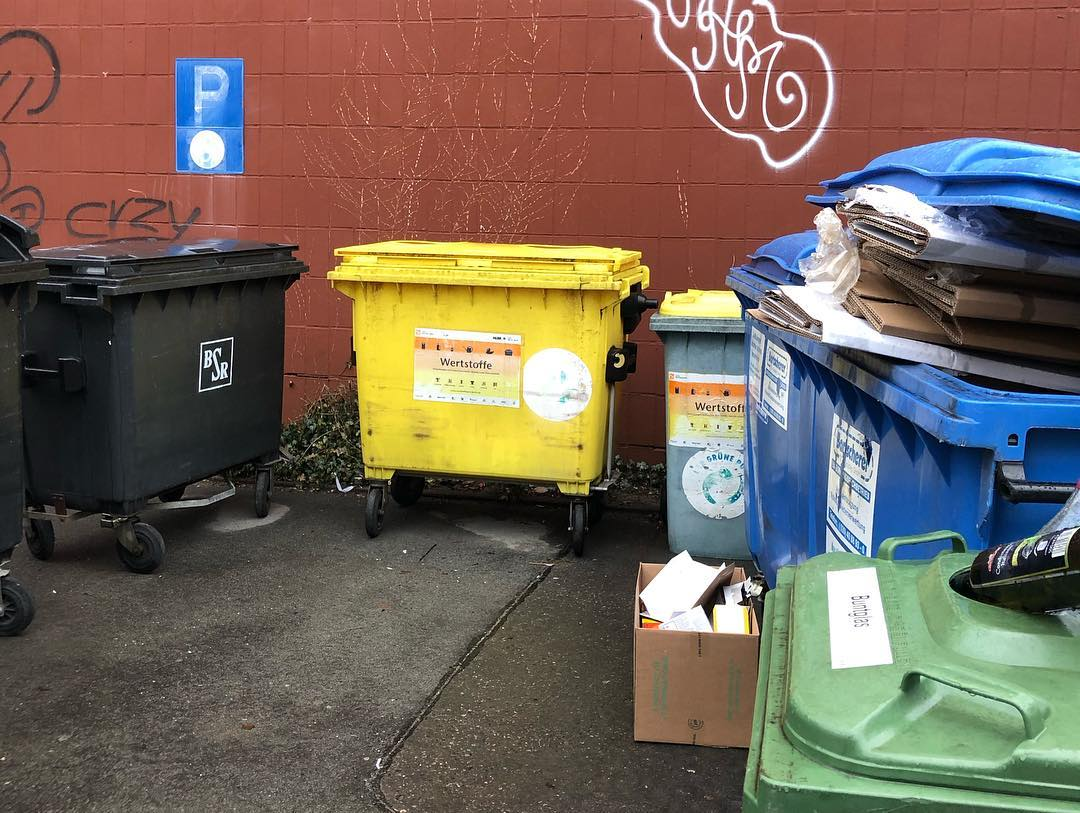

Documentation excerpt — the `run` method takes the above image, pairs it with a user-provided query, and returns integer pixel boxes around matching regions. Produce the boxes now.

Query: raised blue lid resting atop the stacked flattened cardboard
[807,138,1080,221]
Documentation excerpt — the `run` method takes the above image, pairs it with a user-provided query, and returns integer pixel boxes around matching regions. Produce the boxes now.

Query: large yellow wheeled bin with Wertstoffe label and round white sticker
[328,241,657,555]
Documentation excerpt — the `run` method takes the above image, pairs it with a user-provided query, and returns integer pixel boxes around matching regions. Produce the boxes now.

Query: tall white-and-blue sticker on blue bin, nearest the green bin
[825,415,881,556]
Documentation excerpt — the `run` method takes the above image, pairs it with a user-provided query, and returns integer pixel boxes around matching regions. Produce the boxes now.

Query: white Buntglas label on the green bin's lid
[825,568,892,669]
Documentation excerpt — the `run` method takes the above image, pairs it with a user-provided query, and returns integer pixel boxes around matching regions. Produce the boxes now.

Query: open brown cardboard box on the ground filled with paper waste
[634,553,760,748]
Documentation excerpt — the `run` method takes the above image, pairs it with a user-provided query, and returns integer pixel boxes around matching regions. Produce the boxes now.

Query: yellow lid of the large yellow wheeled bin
[329,240,648,290]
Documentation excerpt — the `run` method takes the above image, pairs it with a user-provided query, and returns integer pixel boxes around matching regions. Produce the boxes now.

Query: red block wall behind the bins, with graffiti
[0,0,1080,459]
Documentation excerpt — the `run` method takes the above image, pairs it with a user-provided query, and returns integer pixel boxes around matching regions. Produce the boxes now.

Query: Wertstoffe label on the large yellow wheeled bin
[413,327,522,407]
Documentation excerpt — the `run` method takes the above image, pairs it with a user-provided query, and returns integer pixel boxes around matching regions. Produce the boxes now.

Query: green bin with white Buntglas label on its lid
[743,532,1080,813]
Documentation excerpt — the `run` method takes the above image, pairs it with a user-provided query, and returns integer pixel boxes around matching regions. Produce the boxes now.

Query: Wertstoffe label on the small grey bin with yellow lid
[667,371,746,449]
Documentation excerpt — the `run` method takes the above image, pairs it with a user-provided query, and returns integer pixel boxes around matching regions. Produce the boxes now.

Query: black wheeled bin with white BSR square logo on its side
[23,240,307,573]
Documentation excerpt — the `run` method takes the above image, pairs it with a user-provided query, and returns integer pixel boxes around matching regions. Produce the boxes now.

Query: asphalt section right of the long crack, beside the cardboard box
[381,513,746,813]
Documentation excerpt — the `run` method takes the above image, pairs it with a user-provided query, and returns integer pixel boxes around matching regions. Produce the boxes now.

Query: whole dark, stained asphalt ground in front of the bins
[0,491,745,812]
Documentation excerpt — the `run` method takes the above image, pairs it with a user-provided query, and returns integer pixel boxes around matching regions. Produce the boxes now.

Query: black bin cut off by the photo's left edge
[0,215,46,635]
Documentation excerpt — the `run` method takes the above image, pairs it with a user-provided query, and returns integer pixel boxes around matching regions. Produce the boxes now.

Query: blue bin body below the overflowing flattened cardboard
[728,237,1080,584]
